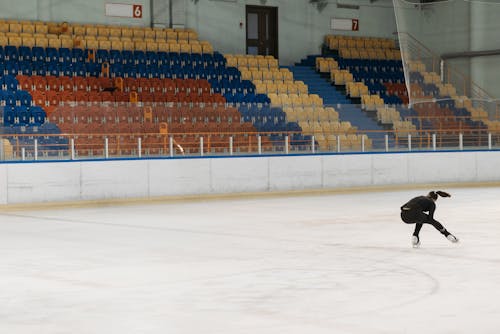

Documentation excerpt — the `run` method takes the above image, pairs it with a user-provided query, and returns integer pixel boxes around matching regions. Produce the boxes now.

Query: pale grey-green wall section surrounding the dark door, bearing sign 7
[186,0,396,65]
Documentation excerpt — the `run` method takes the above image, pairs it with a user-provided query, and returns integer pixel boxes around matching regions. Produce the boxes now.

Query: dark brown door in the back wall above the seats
[246,6,278,59]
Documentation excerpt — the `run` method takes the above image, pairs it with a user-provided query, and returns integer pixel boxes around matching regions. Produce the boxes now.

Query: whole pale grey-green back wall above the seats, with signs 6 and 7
[0,0,396,65]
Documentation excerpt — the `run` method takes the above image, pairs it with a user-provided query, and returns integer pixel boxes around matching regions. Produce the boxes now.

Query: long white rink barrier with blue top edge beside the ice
[0,151,500,204]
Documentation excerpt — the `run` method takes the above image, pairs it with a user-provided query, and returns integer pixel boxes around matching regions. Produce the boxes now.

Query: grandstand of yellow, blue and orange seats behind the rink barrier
[0,1,498,159]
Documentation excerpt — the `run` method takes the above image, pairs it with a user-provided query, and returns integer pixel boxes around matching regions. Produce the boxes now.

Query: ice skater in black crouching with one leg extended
[401,190,458,247]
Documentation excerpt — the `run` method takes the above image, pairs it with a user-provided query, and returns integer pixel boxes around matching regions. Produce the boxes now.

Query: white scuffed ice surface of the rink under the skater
[0,187,500,334]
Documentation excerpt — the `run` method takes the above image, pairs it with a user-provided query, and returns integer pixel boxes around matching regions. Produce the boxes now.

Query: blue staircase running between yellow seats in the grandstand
[290,62,385,147]
